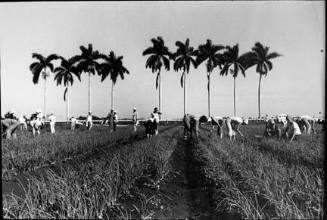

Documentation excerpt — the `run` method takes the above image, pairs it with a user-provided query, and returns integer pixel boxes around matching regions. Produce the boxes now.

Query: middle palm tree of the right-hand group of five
[196,39,224,118]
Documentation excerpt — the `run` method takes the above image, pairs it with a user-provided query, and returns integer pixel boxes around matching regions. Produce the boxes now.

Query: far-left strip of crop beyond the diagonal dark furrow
[2,125,177,178]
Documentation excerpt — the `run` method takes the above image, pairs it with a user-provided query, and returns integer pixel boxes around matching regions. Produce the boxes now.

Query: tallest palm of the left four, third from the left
[76,44,100,112]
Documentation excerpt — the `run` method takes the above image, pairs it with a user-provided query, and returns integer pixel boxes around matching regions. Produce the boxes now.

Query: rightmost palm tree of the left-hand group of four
[99,51,129,109]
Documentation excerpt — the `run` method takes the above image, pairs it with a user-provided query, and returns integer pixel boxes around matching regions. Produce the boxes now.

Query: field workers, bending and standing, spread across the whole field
[1,107,322,141]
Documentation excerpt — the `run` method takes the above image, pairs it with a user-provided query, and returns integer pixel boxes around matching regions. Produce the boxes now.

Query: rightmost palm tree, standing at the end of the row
[250,42,281,118]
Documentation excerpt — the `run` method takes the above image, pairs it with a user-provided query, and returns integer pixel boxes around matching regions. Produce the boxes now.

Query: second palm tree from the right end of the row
[220,44,251,116]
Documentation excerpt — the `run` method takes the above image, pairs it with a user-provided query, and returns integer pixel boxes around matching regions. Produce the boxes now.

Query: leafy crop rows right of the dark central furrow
[199,128,323,218]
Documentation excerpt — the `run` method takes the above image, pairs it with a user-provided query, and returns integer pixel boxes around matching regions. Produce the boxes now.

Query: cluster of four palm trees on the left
[30,44,129,120]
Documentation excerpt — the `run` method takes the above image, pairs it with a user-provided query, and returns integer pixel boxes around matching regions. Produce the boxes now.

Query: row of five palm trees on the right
[143,37,281,118]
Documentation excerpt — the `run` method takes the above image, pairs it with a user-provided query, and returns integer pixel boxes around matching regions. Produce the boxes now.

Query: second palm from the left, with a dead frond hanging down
[54,57,81,121]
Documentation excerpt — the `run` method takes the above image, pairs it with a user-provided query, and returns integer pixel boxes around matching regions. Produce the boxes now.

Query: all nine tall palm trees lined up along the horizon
[30,37,281,119]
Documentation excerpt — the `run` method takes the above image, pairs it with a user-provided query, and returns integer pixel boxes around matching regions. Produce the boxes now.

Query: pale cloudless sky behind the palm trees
[0,1,325,120]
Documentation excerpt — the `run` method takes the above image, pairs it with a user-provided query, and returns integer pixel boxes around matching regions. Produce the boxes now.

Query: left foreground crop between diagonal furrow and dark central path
[3,127,182,219]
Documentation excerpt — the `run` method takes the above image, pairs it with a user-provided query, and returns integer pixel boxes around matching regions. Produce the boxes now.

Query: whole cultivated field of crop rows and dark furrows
[2,123,324,219]
